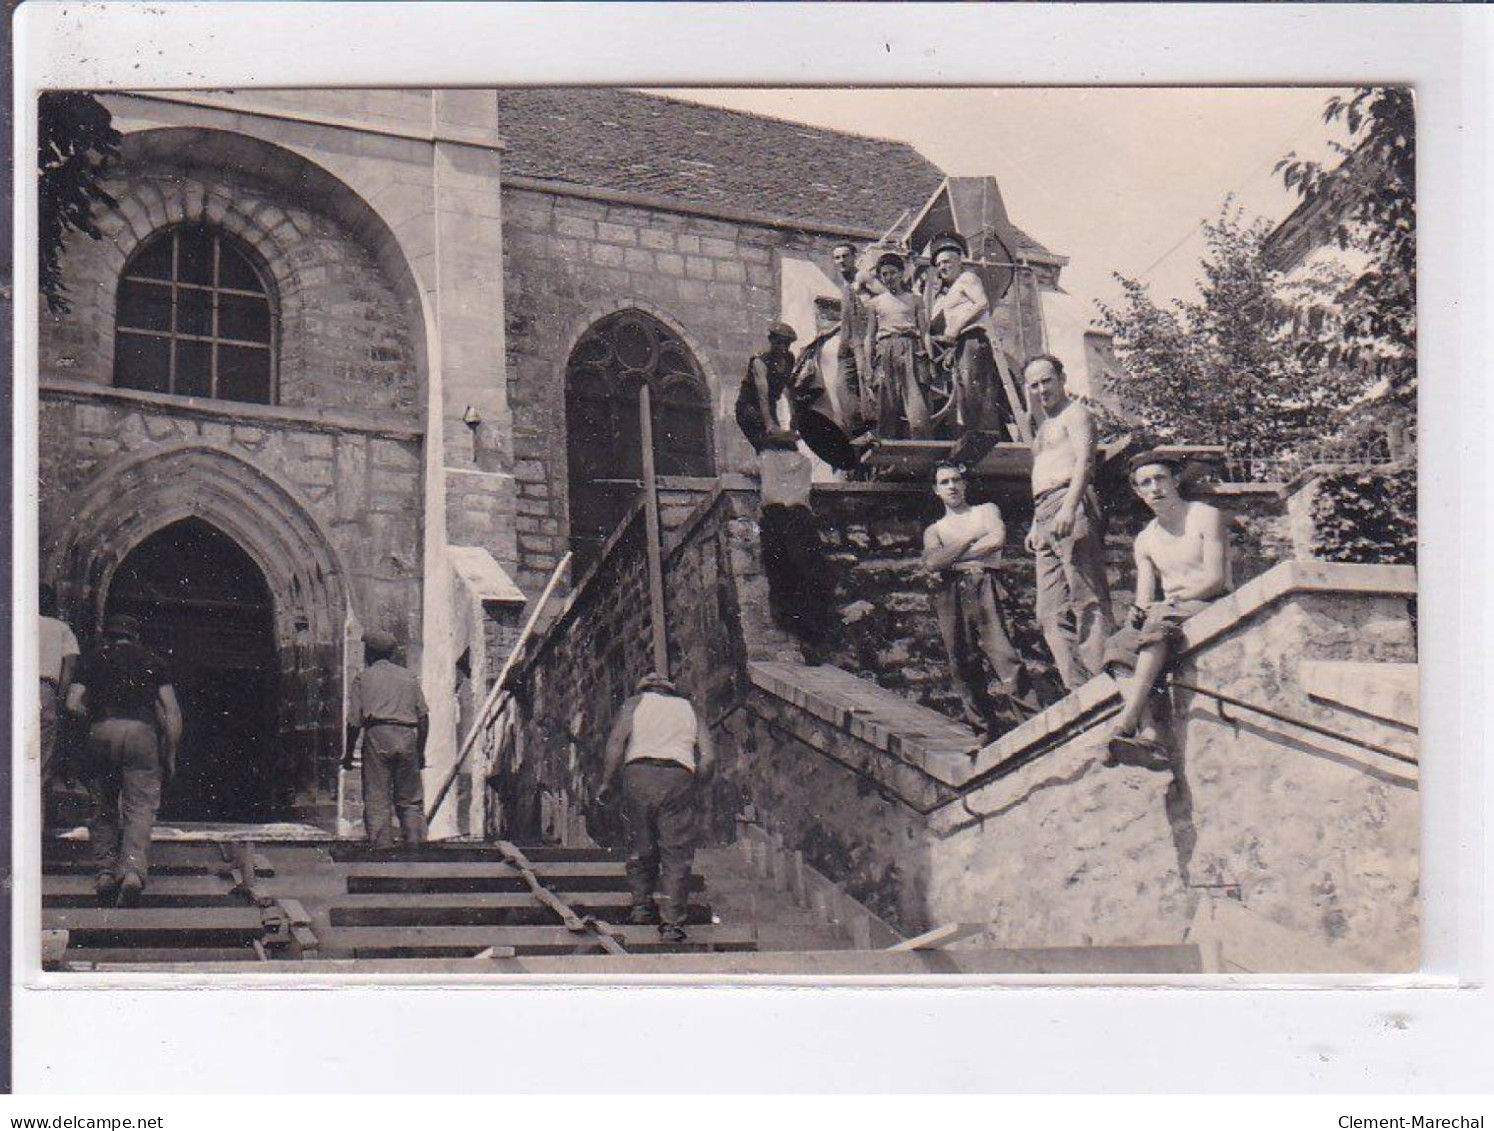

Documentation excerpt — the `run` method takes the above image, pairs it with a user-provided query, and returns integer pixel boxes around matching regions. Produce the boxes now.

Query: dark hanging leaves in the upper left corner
[36,91,120,314]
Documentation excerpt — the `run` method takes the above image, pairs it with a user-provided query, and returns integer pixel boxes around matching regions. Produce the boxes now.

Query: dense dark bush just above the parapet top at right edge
[1312,466,1416,565]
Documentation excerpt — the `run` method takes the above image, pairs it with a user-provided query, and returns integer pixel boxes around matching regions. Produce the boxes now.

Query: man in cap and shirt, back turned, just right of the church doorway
[342,629,430,849]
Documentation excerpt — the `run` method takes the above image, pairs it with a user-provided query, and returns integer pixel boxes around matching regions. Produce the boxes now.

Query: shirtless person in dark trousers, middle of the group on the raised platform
[867,251,934,439]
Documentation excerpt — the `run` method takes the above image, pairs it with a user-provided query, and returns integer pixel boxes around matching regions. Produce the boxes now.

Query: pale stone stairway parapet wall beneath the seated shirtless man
[741,565,1419,973]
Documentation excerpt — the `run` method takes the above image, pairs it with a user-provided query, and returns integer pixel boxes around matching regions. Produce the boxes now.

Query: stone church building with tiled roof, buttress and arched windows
[39,90,1065,835]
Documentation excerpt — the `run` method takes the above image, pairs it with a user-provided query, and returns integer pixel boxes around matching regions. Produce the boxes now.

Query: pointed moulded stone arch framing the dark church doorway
[43,444,351,822]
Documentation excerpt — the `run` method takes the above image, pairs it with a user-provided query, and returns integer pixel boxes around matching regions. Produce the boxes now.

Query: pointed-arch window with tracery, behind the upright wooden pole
[565,311,716,577]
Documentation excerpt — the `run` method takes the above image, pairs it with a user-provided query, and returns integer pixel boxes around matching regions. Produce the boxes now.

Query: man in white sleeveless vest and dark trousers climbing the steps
[598,672,716,943]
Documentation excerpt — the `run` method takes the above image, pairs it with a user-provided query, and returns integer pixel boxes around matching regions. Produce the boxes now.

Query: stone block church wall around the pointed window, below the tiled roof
[502,187,835,592]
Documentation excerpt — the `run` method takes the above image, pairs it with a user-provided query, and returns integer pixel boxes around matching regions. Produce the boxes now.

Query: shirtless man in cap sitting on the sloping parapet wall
[1104,451,1228,759]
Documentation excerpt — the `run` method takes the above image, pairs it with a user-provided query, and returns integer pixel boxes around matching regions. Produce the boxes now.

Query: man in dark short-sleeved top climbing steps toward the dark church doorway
[67,613,182,907]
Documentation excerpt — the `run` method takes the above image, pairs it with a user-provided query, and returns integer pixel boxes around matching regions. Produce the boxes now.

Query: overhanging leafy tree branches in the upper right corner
[1276,87,1416,405]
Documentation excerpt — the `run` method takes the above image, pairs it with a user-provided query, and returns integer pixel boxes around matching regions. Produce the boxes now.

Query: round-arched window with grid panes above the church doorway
[114,224,275,405]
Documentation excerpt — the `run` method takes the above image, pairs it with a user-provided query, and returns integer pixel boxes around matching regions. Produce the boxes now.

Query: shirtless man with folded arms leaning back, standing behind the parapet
[923,463,1038,738]
